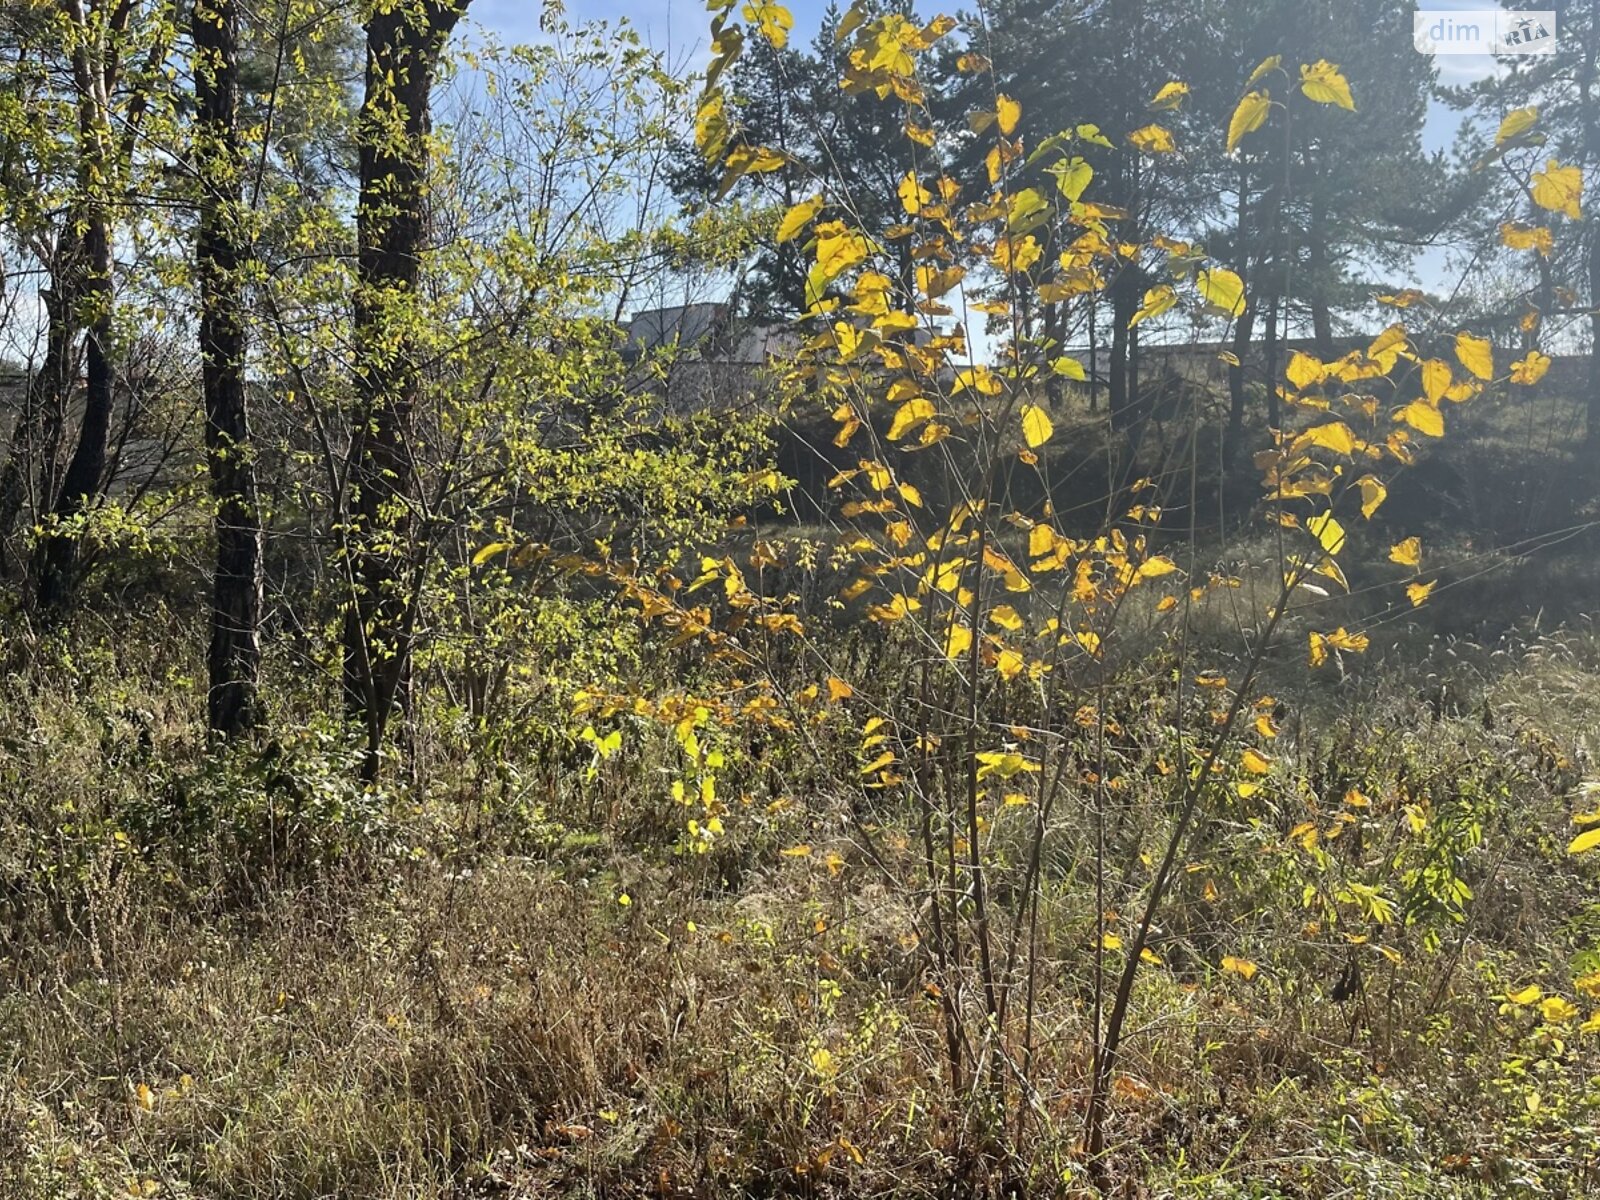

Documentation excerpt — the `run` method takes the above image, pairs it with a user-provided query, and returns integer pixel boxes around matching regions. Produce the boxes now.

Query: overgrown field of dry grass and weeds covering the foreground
[0,544,1600,1200]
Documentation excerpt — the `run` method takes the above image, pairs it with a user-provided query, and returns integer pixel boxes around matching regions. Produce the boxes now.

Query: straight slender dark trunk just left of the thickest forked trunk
[192,0,261,734]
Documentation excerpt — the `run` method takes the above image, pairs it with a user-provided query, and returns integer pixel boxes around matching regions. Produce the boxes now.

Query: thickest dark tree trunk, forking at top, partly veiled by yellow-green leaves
[342,0,467,779]
